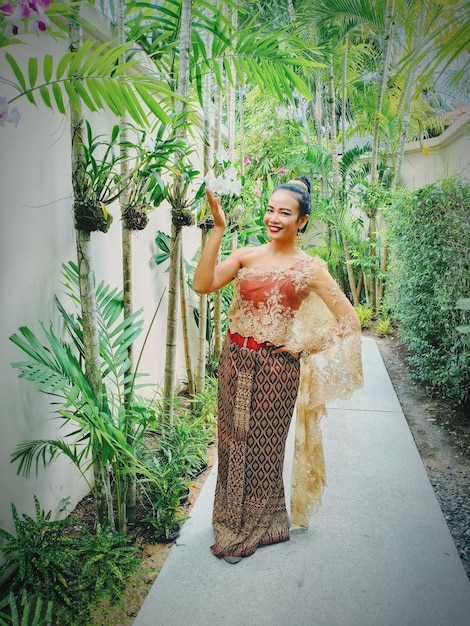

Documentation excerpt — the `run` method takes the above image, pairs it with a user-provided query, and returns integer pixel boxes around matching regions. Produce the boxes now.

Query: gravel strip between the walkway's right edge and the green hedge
[371,334,470,579]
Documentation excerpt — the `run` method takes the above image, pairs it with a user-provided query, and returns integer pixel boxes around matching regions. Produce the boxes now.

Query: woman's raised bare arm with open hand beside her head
[193,187,241,293]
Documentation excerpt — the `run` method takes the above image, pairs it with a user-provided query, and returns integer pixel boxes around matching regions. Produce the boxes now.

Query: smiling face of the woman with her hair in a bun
[263,189,308,240]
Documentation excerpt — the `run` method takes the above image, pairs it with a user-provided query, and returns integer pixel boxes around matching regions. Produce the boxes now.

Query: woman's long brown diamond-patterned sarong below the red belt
[211,339,300,557]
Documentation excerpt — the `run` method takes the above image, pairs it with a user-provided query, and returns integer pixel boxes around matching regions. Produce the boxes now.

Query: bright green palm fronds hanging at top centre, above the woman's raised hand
[126,0,318,105]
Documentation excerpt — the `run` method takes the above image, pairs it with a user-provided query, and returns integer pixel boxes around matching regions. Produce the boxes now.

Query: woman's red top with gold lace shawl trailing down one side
[229,257,363,528]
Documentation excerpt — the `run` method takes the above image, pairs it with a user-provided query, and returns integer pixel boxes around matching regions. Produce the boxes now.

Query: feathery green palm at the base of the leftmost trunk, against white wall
[10,263,160,532]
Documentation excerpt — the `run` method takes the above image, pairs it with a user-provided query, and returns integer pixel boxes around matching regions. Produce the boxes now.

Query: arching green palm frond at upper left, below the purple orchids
[0,1,171,127]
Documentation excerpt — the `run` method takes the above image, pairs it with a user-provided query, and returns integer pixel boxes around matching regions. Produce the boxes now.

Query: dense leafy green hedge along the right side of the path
[386,179,470,403]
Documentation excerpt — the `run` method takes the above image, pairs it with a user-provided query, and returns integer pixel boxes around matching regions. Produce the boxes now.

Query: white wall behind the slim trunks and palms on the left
[0,37,200,531]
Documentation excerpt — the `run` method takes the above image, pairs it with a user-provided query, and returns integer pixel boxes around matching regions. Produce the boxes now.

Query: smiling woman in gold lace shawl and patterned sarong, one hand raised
[193,177,362,563]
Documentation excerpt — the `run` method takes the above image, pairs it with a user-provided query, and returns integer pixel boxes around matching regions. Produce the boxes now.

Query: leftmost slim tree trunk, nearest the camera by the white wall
[69,2,115,530]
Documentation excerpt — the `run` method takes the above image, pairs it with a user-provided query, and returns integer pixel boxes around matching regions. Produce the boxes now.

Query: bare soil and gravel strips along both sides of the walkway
[83,330,470,626]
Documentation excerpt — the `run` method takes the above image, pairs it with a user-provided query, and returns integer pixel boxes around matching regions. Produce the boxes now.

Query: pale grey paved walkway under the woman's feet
[134,339,470,626]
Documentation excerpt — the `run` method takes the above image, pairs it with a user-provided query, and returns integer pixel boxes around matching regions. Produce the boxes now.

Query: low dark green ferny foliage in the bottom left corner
[0,498,141,626]
